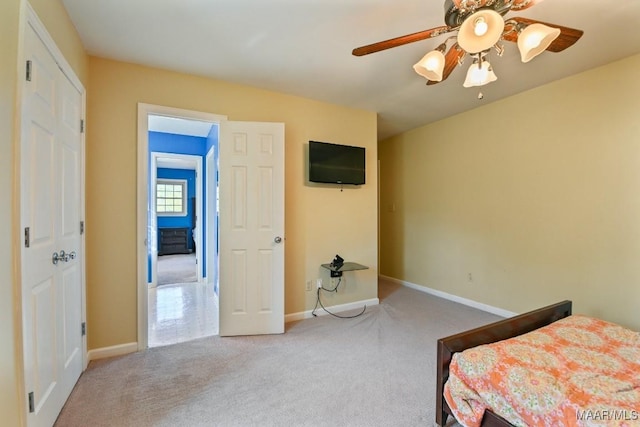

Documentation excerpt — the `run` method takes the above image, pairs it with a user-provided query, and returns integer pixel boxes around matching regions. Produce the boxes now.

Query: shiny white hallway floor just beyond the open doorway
[149,283,218,347]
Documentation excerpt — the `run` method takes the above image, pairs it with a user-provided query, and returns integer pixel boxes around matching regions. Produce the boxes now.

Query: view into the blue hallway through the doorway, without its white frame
[148,149,212,347]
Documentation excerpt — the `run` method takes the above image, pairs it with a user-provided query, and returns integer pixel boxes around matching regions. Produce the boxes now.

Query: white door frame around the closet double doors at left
[13,1,89,424]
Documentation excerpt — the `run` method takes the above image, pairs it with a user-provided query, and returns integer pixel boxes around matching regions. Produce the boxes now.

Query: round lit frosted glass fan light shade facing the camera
[458,9,504,53]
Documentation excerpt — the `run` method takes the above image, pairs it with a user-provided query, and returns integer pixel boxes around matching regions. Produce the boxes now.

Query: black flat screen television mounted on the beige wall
[309,141,365,185]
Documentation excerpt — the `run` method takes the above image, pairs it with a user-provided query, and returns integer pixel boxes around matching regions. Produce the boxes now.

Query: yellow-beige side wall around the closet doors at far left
[0,0,86,426]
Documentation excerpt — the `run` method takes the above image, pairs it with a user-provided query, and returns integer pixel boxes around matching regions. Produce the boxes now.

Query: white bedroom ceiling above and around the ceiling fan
[62,0,640,139]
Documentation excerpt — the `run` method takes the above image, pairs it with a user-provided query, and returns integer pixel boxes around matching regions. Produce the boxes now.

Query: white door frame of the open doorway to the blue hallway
[136,103,227,351]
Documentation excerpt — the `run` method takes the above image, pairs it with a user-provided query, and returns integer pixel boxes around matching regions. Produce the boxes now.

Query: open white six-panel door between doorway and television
[219,121,284,336]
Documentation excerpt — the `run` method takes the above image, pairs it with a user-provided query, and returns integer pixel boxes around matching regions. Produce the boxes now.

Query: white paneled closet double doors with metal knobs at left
[20,20,83,426]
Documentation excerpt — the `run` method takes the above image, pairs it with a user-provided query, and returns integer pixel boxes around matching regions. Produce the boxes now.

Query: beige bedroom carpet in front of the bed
[56,283,499,427]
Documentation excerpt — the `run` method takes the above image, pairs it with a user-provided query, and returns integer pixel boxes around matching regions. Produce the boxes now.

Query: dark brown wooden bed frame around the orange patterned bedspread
[436,300,571,426]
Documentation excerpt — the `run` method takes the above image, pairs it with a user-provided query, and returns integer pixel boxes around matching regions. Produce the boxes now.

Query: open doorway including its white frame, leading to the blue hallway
[138,104,224,349]
